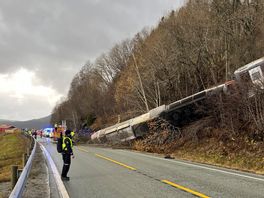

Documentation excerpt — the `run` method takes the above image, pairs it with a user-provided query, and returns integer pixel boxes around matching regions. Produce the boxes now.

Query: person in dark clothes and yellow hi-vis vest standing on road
[61,130,74,181]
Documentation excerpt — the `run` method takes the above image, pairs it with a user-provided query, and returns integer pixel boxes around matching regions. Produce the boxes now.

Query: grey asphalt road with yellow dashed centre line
[39,138,264,198]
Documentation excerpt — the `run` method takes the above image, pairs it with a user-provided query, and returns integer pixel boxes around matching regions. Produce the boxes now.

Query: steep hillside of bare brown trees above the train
[52,0,264,129]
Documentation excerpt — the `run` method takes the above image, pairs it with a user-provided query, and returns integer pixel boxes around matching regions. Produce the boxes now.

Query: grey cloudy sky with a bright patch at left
[0,0,185,120]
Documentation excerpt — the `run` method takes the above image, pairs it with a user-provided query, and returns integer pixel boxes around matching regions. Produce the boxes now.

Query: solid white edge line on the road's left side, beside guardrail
[40,144,70,198]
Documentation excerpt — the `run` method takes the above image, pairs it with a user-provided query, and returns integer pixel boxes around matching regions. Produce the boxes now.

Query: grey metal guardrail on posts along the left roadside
[9,137,37,198]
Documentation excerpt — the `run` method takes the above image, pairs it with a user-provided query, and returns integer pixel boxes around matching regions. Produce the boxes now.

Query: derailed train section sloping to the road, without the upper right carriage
[91,82,231,143]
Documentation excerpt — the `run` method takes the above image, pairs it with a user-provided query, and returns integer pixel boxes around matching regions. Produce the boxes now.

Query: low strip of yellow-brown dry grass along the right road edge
[172,138,264,174]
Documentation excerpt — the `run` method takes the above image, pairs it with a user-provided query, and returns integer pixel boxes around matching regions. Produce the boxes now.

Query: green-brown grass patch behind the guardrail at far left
[0,134,29,182]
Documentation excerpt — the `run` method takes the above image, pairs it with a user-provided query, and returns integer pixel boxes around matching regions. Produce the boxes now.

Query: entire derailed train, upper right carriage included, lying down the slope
[91,57,264,143]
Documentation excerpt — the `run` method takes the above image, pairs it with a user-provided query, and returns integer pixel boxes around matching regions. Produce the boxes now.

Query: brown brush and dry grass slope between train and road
[133,91,264,174]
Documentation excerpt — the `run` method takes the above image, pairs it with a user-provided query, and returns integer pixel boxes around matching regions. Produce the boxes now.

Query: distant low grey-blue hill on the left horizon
[0,115,51,129]
